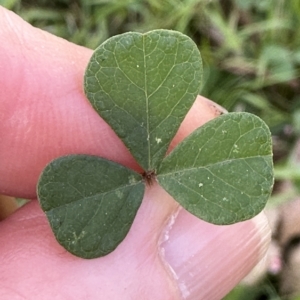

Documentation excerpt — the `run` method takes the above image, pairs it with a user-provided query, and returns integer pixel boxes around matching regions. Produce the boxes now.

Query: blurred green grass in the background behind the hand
[0,0,300,300]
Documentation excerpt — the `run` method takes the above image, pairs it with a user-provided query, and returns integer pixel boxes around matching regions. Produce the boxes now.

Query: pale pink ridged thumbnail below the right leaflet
[160,209,270,300]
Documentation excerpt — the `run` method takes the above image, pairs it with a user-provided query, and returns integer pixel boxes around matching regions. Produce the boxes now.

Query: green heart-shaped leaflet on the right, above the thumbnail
[157,113,273,225]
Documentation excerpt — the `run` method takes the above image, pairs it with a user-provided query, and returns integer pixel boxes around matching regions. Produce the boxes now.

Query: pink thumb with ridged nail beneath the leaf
[0,186,270,300]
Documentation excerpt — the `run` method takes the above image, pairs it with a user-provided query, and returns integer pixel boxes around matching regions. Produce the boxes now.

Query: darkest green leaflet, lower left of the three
[38,155,145,258]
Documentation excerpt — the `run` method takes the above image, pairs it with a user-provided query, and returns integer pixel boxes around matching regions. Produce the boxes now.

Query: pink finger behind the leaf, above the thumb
[0,7,220,198]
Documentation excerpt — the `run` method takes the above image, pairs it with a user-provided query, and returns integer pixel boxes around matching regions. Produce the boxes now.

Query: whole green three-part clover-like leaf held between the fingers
[38,30,273,258]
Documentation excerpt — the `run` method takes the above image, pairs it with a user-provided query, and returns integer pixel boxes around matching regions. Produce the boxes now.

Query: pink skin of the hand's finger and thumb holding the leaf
[0,7,270,300]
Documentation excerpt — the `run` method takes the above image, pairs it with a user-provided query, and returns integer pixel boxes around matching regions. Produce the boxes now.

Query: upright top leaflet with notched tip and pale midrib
[84,30,202,170]
